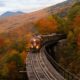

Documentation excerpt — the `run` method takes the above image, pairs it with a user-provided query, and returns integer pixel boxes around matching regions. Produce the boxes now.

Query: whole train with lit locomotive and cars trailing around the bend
[30,33,66,52]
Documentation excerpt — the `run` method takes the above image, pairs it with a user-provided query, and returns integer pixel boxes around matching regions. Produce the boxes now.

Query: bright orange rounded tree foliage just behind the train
[36,18,57,34]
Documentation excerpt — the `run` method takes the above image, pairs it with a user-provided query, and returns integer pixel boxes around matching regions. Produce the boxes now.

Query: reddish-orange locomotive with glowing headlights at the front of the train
[30,36,41,52]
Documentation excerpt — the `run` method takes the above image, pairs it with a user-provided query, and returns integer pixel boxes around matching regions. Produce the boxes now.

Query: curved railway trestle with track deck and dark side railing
[26,35,79,80]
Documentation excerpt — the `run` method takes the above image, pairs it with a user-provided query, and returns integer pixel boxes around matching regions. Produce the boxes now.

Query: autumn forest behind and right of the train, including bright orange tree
[36,2,80,77]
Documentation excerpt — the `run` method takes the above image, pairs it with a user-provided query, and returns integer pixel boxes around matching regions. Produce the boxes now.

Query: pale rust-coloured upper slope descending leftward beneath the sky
[0,1,73,33]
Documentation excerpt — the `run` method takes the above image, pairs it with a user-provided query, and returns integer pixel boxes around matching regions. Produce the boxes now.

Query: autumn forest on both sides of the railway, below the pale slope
[0,2,80,80]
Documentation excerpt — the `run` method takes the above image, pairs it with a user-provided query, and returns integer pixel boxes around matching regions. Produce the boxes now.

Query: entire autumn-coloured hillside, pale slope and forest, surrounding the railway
[0,0,80,80]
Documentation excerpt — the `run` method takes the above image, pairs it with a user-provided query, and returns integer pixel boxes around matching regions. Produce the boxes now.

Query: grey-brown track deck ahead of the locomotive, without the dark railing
[27,47,63,80]
